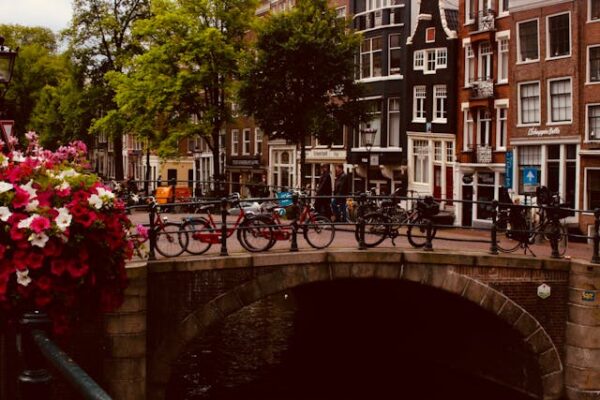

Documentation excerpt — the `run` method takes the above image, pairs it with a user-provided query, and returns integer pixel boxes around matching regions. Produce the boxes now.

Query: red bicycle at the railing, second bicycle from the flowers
[180,194,272,255]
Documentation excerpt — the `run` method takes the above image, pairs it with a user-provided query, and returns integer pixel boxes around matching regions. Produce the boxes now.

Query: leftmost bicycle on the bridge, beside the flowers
[132,196,189,257]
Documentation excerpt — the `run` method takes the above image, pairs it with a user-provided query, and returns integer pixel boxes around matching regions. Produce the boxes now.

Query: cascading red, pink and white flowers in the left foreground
[0,132,134,334]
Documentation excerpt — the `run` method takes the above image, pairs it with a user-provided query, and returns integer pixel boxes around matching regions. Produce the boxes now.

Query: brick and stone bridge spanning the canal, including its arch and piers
[100,249,600,400]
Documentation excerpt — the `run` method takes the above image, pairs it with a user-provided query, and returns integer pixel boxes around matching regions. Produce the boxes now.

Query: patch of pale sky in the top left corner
[0,0,71,35]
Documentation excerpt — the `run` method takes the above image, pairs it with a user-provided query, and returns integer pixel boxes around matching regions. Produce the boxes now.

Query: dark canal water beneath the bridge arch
[167,284,532,400]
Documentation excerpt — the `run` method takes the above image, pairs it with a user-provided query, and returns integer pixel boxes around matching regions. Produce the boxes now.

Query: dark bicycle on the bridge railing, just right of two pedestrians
[355,196,439,248]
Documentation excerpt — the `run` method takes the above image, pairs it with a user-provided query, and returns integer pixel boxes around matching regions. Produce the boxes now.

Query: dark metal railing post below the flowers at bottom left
[17,311,52,400]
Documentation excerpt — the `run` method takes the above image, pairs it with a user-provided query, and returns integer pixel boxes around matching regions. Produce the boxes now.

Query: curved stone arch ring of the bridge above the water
[148,252,564,400]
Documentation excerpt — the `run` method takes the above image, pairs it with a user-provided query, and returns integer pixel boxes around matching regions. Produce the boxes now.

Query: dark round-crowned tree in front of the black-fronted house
[239,0,366,186]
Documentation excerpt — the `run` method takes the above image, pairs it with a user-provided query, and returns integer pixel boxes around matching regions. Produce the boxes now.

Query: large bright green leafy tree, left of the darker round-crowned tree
[110,0,256,192]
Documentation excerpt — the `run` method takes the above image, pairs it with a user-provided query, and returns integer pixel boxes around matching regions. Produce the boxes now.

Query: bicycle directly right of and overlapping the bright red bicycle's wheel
[256,195,335,250]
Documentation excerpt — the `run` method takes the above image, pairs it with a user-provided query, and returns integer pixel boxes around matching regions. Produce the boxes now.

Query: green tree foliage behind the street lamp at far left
[0,25,65,137]
